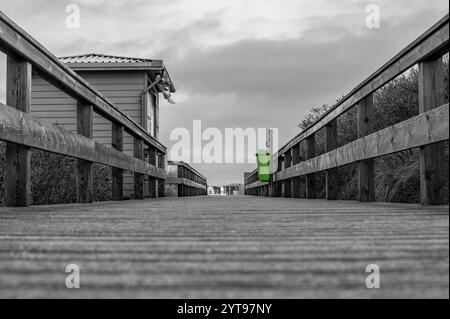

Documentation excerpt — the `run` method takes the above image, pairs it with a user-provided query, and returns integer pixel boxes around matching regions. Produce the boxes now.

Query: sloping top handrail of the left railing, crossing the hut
[0,12,166,153]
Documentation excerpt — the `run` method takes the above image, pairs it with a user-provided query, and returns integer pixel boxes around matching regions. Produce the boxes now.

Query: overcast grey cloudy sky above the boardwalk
[0,0,448,184]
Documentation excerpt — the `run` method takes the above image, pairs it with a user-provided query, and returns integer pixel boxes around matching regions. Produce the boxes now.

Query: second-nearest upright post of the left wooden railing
[76,101,94,203]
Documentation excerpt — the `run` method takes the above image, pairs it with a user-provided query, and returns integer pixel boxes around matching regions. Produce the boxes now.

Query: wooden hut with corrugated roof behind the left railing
[31,54,175,197]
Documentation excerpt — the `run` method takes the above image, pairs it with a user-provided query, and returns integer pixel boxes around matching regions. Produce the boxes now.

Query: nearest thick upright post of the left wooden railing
[5,56,33,206]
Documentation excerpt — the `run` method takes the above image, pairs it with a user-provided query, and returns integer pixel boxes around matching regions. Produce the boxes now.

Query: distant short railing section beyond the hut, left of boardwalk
[165,161,208,197]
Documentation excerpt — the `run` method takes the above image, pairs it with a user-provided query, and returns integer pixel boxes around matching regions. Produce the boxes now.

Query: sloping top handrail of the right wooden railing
[272,14,449,158]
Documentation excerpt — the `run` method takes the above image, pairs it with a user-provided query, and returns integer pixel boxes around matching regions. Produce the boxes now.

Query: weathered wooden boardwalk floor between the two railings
[0,196,449,298]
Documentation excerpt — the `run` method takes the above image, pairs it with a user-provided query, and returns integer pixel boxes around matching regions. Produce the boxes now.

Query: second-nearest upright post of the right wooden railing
[357,94,375,202]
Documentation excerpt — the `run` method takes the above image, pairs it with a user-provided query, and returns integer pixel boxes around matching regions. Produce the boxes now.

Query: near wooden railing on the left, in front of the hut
[0,12,166,206]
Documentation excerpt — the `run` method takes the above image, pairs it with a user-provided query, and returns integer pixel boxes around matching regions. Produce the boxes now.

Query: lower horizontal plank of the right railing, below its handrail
[273,104,449,181]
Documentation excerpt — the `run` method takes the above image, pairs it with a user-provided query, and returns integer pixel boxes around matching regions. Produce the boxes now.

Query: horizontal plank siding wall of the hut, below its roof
[31,71,146,197]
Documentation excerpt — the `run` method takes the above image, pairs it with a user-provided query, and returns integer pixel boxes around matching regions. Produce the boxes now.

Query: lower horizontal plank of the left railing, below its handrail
[0,103,166,179]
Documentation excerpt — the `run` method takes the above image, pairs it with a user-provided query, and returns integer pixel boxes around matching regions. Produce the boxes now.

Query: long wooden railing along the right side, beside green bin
[244,15,449,204]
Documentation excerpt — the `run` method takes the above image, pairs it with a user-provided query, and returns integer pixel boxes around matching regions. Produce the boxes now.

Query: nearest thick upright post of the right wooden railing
[419,57,446,205]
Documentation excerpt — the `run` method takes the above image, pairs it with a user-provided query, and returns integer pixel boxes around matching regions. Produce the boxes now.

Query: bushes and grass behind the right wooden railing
[299,60,449,202]
